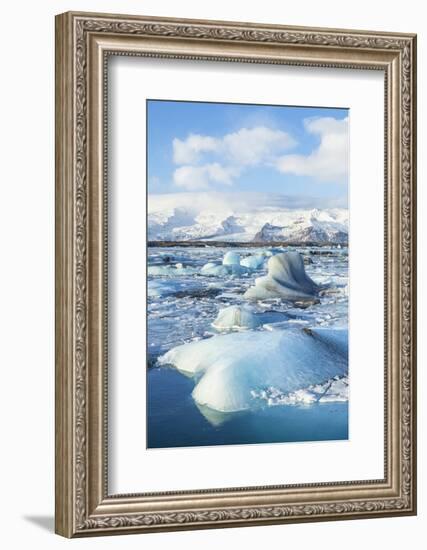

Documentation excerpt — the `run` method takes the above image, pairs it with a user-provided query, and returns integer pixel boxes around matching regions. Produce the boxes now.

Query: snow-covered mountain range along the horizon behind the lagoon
[148,193,348,244]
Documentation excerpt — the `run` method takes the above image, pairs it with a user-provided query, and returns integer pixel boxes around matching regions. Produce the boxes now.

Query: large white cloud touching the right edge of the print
[275,117,348,183]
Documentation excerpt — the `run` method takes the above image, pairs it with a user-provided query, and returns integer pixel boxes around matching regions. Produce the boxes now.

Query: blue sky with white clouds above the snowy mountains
[147,100,348,206]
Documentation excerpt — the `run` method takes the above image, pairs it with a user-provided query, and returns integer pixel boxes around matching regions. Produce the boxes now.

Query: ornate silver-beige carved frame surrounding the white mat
[55,12,416,537]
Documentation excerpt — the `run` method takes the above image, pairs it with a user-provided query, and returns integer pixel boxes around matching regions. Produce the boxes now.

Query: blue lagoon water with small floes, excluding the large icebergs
[147,247,348,447]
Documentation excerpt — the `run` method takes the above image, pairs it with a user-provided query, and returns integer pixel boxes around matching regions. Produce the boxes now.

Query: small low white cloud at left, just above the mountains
[173,162,238,191]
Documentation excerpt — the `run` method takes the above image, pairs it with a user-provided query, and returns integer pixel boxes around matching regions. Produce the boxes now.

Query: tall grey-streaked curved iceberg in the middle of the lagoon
[244,252,319,301]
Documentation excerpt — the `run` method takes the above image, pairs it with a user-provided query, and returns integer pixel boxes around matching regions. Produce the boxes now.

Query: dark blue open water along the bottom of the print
[147,367,348,448]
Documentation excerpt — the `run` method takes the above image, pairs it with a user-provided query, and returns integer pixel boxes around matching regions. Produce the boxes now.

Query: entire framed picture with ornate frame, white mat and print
[56,12,416,537]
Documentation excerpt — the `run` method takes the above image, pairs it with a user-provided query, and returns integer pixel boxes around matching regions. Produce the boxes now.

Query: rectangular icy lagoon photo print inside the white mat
[147,99,350,448]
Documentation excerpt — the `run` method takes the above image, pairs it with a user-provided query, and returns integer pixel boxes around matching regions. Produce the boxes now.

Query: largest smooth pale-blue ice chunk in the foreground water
[158,329,347,412]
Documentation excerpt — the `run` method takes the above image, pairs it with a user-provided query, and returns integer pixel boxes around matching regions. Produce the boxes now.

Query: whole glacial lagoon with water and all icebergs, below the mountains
[147,246,349,448]
